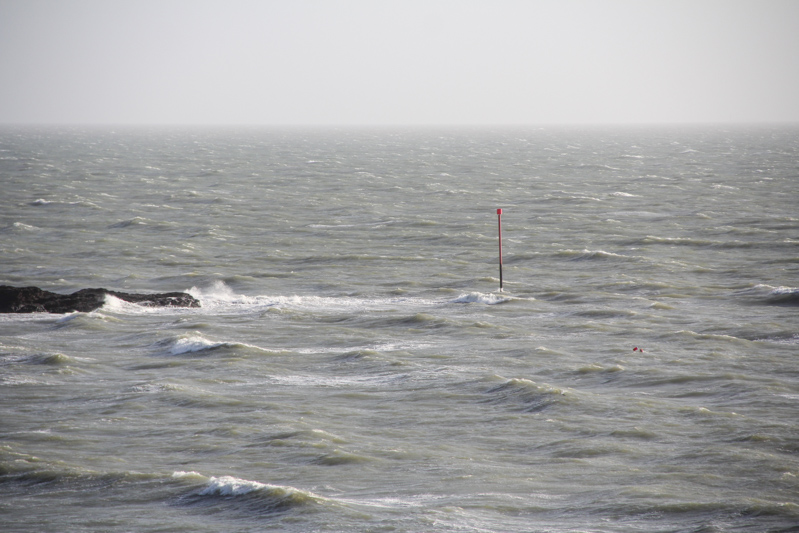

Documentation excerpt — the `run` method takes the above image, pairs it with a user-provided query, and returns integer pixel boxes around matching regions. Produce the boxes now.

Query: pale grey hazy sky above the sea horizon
[0,0,799,125]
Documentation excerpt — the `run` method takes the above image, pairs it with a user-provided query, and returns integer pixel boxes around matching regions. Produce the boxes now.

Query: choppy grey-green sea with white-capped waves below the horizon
[0,124,799,533]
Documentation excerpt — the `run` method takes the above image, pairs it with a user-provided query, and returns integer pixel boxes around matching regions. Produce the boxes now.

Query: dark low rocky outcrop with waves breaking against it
[0,285,200,313]
